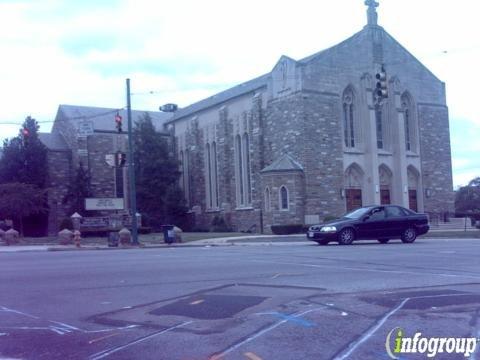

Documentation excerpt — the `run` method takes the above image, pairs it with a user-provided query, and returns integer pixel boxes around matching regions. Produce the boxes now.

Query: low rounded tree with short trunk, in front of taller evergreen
[0,183,47,235]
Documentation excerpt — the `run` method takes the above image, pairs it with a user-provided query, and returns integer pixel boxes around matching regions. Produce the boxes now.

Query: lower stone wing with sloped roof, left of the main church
[40,105,171,235]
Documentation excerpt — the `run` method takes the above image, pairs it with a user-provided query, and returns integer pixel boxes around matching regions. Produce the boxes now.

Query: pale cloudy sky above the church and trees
[0,0,480,187]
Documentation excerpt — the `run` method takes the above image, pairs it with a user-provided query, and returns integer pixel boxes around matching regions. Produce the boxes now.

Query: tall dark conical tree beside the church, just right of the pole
[134,113,187,226]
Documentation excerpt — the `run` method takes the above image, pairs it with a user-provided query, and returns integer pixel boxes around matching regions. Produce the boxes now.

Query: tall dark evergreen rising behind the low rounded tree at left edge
[0,116,47,189]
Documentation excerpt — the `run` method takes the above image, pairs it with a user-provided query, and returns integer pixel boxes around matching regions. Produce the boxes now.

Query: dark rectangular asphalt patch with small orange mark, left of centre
[149,295,267,320]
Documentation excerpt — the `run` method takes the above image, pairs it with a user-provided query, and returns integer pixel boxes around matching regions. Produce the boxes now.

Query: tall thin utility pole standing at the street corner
[127,79,140,245]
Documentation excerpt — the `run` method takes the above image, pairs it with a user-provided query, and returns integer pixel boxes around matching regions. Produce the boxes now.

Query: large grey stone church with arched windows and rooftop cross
[165,0,453,232]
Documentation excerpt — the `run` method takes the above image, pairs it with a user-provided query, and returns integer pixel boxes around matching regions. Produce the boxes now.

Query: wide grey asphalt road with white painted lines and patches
[0,239,480,360]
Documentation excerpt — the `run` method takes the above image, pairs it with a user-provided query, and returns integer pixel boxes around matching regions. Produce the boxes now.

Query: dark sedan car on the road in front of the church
[307,205,430,245]
